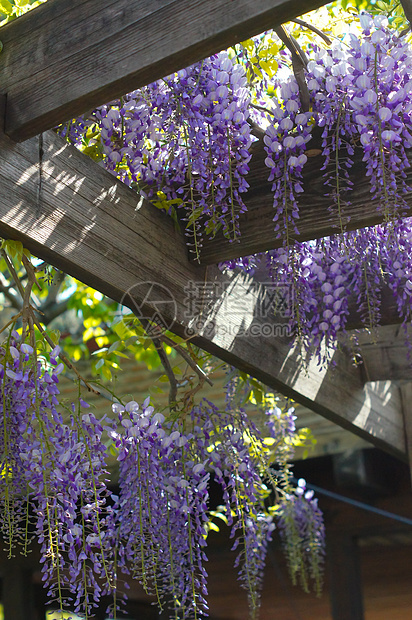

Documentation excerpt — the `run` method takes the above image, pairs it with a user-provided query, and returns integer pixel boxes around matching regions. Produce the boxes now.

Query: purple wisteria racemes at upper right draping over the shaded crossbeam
[264,15,412,234]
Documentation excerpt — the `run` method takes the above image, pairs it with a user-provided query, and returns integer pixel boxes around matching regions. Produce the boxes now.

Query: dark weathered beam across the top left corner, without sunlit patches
[0,0,325,140]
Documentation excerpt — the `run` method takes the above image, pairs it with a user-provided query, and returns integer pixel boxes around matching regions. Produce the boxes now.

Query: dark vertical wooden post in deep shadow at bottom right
[327,531,364,620]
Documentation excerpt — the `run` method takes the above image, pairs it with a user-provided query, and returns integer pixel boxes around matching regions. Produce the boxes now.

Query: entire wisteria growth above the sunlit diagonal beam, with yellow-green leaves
[59,14,412,363]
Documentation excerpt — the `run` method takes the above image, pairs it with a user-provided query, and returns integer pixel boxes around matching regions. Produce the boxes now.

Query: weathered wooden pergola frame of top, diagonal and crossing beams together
[0,0,412,470]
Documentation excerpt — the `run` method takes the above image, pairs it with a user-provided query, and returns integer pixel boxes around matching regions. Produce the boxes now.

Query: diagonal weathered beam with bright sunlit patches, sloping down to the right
[0,122,406,458]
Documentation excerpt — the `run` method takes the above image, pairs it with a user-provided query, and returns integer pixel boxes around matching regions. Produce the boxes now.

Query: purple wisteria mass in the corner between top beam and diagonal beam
[60,52,251,256]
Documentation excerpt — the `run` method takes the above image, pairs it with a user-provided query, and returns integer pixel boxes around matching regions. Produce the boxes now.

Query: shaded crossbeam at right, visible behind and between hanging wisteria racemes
[196,141,412,265]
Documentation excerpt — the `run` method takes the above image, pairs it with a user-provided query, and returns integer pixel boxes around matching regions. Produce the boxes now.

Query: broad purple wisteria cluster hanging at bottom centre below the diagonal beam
[111,399,209,618]
